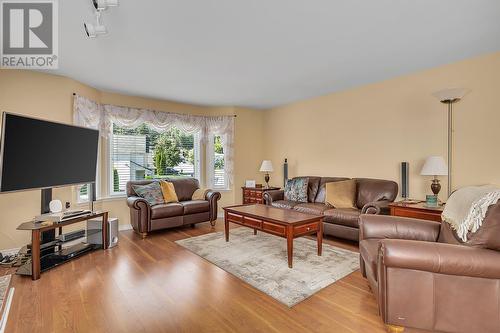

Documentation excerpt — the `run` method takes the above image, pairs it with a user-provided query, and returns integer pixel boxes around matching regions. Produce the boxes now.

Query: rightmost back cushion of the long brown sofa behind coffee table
[356,178,398,209]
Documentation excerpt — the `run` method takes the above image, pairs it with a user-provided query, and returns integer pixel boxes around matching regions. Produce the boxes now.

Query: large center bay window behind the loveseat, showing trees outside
[109,124,200,195]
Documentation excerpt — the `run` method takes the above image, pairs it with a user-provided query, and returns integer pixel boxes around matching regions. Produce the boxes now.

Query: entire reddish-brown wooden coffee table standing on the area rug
[224,204,323,268]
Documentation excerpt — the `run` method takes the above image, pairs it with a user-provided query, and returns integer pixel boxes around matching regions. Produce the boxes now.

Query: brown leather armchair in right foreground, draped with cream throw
[359,201,500,333]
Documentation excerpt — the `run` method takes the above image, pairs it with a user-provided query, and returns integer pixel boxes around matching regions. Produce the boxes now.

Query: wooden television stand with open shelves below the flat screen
[17,212,109,280]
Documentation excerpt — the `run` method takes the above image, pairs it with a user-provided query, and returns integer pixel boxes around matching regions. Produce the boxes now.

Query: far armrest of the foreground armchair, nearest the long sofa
[359,214,441,242]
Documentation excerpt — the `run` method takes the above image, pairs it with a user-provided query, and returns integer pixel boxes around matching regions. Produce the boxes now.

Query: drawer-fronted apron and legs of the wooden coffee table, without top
[224,205,323,268]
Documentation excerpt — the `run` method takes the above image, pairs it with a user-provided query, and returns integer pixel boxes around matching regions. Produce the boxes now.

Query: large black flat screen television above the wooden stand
[0,112,99,192]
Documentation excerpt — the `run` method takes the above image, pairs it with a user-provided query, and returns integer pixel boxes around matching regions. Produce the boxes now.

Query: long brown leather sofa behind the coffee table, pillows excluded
[264,177,398,241]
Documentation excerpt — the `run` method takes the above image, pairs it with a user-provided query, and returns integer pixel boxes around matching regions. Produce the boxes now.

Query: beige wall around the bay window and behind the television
[0,70,263,249]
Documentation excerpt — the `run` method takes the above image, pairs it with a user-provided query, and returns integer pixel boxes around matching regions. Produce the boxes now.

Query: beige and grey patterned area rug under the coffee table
[176,228,359,307]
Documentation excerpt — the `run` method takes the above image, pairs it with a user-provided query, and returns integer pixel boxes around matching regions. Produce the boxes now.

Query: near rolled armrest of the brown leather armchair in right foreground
[379,239,500,279]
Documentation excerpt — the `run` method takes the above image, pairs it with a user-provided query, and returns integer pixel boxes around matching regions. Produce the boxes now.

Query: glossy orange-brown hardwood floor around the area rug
[6,221,426,333]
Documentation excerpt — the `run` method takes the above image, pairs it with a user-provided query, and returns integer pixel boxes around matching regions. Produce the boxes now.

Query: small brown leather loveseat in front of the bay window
[127,177,221,237]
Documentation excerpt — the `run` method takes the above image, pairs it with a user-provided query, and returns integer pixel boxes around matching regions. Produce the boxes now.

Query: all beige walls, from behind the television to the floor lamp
[0,53,500,249]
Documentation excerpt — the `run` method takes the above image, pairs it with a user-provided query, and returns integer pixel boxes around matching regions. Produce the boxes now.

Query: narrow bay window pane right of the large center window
[207,135,229,189]
